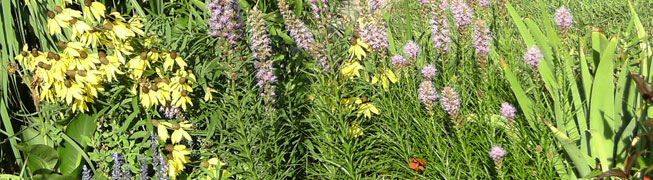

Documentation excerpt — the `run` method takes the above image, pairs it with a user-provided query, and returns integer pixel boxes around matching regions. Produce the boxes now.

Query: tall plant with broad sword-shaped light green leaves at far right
[504,0,650,179]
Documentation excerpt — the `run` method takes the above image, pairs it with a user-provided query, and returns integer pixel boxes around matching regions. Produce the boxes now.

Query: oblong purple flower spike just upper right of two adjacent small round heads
[430,13,451,52]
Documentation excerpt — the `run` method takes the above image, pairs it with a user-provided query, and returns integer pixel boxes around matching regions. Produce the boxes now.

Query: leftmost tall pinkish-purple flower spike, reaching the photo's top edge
[206,0,244,44]
